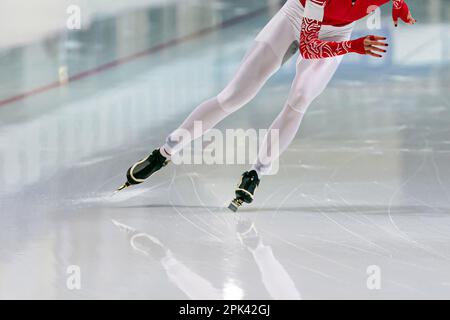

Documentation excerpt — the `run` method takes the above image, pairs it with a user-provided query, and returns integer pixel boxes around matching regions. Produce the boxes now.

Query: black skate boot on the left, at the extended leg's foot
[117,149,170,191]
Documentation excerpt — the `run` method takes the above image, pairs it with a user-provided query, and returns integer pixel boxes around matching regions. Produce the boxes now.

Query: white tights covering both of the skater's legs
[163,9,352,175]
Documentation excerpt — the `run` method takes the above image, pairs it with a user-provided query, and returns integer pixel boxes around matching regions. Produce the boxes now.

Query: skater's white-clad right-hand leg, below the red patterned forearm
[252,29,351,176]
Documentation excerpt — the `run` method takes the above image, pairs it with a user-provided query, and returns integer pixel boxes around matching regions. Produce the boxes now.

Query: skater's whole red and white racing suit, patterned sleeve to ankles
[161,0,409,175]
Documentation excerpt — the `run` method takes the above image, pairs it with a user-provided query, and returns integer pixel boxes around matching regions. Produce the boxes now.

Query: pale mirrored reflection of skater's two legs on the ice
[112,217,302,300]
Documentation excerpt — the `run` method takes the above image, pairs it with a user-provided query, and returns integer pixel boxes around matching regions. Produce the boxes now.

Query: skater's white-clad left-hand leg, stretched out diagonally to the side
[161,12,296,156]
